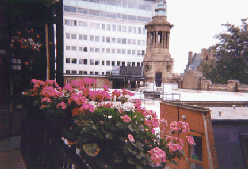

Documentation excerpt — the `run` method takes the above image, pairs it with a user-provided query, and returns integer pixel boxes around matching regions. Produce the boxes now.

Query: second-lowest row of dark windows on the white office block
[66,58,143,67]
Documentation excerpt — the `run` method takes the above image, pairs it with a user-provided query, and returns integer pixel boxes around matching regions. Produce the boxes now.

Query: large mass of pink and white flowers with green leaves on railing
[24,78,195,166]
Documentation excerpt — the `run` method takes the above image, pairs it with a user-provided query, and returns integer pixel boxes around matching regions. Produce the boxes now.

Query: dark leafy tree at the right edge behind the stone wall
[201,21,248,84]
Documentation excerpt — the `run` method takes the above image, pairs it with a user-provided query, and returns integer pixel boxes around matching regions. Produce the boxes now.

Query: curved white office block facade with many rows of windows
[63,0,165,87]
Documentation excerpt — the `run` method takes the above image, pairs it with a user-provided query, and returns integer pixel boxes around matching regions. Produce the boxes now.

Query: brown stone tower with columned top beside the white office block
[143,1,173,87]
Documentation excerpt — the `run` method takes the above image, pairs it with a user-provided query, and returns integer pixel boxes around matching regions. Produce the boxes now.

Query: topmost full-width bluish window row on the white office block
[64,6,152,23]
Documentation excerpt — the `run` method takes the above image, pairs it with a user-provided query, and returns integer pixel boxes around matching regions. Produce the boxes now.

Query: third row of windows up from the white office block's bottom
[66,46,145,56]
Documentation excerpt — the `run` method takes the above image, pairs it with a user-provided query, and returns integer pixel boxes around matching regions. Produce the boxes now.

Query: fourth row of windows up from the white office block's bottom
[65,33,145,46]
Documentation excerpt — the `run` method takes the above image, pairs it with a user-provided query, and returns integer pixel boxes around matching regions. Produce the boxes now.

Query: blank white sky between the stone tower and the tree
[167,0,248,73]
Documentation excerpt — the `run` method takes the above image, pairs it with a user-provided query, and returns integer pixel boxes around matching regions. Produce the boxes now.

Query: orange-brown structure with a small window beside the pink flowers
[160,102,219,169]
